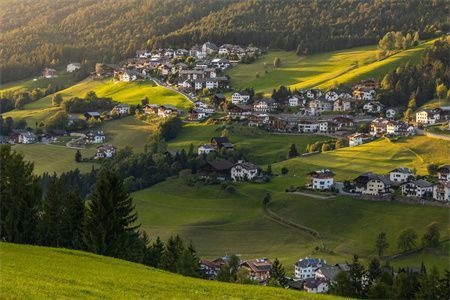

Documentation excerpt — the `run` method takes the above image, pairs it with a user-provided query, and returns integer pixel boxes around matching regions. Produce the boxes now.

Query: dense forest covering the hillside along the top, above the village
[0,0,449,83]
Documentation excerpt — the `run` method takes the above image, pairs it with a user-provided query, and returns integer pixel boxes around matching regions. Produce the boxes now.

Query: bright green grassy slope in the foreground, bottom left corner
[0,243,335,299]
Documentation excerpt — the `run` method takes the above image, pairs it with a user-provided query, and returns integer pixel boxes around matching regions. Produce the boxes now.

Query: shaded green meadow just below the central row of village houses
[168,123,330,164]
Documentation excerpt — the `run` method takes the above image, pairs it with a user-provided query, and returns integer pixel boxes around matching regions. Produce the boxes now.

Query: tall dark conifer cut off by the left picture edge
[0,145,42,244]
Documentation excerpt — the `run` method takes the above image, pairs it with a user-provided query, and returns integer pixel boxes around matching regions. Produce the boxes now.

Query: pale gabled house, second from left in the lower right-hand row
[354,172,392,196]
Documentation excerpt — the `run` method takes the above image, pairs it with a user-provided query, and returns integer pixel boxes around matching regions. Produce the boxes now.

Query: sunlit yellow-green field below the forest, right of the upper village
[228,41,432,93]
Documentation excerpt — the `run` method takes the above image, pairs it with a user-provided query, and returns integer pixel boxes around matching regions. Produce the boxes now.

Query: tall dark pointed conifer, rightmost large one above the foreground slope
[84,169,140,259]
